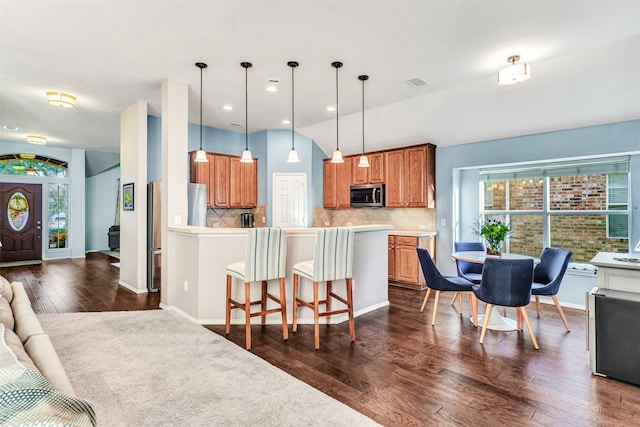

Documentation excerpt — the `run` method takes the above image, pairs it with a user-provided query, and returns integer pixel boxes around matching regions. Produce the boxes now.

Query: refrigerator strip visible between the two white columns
[147,181,162,292]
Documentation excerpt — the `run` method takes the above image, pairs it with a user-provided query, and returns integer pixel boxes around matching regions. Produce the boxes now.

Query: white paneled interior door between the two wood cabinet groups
[272,173,307,228]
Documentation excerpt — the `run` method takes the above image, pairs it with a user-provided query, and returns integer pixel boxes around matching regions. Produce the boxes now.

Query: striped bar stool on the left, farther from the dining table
[225,228,289,350]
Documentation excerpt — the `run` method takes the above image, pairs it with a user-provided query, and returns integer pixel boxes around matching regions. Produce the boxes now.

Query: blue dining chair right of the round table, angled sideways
[531,248,571,332]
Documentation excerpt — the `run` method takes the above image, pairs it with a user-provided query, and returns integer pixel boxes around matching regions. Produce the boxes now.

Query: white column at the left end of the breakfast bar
[160,79,189,305]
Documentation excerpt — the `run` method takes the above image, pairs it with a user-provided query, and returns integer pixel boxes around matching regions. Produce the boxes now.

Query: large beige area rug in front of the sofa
[38,310,377,427]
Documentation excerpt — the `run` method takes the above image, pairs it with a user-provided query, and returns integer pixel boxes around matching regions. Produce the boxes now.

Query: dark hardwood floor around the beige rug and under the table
[0,253,640,426]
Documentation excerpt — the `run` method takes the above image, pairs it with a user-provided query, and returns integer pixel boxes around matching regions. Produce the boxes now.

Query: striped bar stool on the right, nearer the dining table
[293,228,356,350]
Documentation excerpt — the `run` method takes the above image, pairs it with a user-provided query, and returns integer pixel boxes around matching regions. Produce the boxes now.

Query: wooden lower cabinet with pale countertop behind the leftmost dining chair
[388,234,435,290]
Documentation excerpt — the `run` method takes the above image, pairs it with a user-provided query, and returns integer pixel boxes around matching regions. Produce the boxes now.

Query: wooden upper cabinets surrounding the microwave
[324,144,436,209]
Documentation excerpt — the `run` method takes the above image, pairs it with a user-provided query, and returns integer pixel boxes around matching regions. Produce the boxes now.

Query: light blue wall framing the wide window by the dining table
[436,120,640,274]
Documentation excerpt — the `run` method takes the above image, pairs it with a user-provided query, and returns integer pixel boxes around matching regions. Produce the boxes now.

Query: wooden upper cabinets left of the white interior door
[189,151,258,208]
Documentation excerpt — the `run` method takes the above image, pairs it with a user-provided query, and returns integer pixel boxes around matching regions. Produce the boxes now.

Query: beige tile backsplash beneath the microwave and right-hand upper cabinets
[313,206,436,231]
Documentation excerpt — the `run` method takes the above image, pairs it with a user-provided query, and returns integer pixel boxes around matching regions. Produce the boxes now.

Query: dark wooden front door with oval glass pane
[0,183,42,262]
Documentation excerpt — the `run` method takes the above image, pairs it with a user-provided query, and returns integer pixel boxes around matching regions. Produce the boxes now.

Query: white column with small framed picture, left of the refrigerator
[120,101,147,293]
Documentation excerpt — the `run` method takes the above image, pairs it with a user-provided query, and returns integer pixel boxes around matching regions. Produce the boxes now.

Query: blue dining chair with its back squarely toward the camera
[473,258,540,350]
